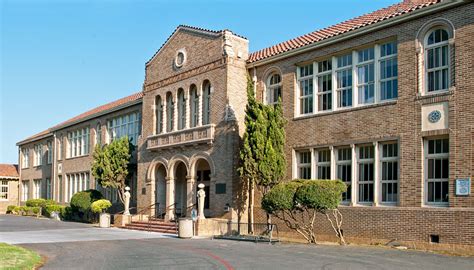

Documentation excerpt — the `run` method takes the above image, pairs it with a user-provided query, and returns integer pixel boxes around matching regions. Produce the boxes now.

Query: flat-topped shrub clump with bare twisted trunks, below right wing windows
[262,180,347,245]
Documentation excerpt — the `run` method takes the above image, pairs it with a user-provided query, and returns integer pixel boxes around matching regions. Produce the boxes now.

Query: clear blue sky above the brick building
[0,0,401,163]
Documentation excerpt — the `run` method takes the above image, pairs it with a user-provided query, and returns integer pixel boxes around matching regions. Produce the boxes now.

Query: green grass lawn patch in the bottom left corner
[0,243,41,270]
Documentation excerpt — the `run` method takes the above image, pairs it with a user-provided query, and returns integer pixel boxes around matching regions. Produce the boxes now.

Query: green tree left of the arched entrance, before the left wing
[92,136,134,204]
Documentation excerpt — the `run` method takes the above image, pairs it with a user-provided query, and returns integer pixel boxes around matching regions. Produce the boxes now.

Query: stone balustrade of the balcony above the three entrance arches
[147,124,215,150]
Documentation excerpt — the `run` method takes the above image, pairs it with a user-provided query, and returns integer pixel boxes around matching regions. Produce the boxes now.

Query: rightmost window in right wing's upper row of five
[380,42,398,101]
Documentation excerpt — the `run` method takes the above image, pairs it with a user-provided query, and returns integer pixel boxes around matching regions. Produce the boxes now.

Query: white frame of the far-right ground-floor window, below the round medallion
[423,137,450,207]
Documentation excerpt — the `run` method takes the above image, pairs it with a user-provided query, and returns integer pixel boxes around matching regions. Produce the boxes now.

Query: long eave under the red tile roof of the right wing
[247,0,469,68]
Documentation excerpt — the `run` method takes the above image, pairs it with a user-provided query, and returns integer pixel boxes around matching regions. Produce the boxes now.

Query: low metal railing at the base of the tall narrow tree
[219,221,280,243]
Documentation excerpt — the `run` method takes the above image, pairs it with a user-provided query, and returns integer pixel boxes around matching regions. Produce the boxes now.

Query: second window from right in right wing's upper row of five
[357,47,375,104]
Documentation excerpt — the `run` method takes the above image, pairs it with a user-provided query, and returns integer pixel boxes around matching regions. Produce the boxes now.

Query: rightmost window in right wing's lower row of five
[380,142,399,203]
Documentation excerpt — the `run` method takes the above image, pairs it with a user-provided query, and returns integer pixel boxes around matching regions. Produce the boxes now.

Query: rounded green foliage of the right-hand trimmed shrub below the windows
[295,180,347,211]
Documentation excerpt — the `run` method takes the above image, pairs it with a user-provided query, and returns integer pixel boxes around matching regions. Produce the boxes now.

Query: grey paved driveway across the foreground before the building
[0,216,474,270]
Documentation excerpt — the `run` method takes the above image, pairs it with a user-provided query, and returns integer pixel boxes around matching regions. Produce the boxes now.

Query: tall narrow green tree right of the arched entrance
[239,76,286,231]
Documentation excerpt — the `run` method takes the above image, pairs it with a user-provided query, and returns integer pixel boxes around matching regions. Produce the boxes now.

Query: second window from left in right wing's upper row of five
[317,60,332,111]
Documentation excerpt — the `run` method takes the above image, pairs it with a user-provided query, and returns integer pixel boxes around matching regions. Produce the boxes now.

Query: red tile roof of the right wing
[248,0,441,63]
